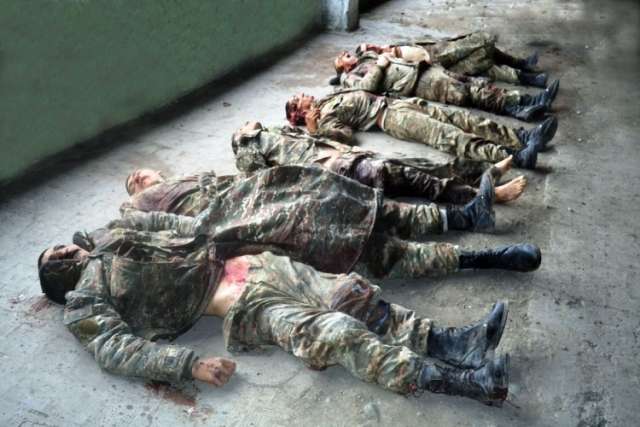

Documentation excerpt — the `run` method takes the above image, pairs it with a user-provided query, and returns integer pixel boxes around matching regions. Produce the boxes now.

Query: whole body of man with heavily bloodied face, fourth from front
[285,89,557,169]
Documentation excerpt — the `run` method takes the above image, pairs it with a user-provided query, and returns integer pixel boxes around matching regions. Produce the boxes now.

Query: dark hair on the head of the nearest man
[38,246,82,304]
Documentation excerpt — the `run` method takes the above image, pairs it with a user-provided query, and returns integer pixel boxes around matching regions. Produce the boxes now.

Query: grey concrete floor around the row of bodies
[0,0,640,427]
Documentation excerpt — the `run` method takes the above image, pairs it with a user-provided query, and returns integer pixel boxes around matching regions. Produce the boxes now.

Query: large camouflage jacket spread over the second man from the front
[124,166,382,273]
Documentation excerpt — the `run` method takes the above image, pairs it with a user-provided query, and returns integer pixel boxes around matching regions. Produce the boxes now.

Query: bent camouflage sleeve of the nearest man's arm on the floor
[64,259,198,383]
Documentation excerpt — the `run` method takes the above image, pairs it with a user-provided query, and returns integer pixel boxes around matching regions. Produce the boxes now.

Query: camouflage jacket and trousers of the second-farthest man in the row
[340,52,520,113]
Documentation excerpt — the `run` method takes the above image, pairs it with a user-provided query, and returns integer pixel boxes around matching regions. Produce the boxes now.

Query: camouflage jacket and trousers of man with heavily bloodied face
[316,90,523,163]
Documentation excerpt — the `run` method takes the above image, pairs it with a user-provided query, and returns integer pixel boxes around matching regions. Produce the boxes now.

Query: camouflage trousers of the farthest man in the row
[426,32,522,84]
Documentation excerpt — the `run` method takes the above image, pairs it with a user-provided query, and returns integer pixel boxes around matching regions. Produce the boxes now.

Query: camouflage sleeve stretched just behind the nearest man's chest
[114,209,198,237]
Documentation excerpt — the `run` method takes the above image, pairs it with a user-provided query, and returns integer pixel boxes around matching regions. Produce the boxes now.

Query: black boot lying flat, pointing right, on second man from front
[459,243,542,272]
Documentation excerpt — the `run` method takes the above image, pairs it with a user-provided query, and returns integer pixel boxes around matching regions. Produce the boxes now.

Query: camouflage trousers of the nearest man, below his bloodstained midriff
[224,252,431,394]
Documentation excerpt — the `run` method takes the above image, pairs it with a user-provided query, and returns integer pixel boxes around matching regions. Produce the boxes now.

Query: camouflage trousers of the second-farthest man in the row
[414,65,520,113]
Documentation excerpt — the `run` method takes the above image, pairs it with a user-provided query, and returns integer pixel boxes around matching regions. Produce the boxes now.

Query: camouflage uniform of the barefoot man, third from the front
[232,126,490,205]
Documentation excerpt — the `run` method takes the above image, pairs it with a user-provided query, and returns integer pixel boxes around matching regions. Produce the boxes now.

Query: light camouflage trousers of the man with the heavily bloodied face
[382,98,523,163]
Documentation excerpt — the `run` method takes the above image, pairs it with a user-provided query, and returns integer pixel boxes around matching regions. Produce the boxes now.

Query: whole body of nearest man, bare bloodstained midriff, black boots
[38,226,508,404]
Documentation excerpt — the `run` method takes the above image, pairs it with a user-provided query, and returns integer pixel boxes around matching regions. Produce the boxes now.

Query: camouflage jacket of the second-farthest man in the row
[340,52,426,96]
